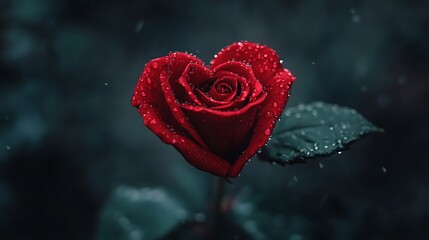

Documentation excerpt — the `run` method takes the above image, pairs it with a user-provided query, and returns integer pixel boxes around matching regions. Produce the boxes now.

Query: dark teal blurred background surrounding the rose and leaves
[0,0,429,240]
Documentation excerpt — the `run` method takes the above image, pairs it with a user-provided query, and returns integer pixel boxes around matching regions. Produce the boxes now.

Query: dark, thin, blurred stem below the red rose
[212,177,225,240]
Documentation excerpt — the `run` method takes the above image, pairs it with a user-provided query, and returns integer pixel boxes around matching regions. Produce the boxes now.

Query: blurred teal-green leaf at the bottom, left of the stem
[97,186,188,240]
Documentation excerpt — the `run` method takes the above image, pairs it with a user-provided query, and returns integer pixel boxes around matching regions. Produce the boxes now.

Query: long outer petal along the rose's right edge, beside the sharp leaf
[227,69,295,177]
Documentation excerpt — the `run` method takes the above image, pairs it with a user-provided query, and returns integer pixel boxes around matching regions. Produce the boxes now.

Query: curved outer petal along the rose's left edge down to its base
[132,57,230,176]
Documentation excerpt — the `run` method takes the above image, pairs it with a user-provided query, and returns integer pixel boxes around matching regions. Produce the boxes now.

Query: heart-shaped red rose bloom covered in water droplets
[132,42,295,177]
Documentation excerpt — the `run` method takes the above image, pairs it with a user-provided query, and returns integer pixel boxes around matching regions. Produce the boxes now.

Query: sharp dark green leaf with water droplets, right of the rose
[258,102,382,165]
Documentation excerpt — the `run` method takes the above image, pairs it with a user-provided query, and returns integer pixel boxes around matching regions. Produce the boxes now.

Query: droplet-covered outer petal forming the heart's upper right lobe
[210,42,283,85]
